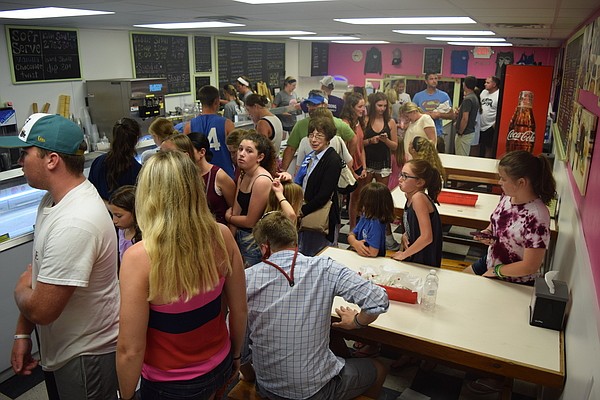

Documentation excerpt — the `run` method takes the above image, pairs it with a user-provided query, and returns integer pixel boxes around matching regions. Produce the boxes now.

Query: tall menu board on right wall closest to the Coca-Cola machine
[557,30,583,153]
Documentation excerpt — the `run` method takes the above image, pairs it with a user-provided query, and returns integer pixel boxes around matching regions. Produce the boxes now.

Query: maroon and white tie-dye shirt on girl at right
[487,195,550,282]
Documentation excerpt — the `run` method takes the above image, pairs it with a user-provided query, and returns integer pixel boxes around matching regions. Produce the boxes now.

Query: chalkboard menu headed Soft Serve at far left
[6,26,81,83]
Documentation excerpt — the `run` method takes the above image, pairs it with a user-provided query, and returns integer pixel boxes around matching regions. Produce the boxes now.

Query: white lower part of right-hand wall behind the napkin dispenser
[553,152,600,400]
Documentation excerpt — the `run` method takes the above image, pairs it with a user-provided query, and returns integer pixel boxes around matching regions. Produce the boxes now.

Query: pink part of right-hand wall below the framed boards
[572,90,600,298]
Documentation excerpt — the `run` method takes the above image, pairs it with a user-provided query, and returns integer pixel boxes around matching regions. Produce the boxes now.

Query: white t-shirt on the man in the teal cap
[32,179,120,371]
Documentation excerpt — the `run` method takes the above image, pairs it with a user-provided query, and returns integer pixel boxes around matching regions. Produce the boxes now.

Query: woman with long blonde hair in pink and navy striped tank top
[117,151,247,399]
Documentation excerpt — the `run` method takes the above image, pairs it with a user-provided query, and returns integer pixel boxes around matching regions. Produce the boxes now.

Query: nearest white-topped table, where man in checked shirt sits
[321,247,565,388]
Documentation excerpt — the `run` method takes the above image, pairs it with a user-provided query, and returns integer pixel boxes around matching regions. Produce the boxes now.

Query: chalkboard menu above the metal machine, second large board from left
[131,33,191,94]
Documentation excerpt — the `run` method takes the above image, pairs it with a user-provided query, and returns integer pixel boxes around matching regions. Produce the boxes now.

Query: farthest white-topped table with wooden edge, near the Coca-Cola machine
[439,153,499,185]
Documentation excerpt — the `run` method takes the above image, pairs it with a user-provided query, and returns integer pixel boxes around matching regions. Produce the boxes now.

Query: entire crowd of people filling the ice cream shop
[0,74,555,400]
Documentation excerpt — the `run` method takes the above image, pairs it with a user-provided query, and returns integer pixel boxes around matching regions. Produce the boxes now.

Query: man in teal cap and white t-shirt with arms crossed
[0,113,119,400]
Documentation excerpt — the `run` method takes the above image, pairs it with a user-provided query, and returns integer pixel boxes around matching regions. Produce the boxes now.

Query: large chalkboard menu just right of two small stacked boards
[217,39,285,88]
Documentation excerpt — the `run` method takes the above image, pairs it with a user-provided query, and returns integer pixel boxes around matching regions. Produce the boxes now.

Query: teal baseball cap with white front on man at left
[0,113,83,155]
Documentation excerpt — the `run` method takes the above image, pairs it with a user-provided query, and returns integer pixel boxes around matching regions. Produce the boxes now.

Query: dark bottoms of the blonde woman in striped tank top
[139,353,233,400]
